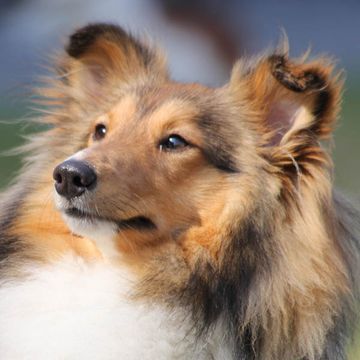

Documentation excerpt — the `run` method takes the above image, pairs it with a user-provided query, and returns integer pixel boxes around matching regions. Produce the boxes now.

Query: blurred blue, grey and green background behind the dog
[0,0,360,360]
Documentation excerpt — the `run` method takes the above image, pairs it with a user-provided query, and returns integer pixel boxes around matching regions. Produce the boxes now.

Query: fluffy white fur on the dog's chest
[0,256,224,360]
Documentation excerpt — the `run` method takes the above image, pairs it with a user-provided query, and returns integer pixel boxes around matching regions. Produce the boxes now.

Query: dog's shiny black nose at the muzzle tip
[53,160,96,199]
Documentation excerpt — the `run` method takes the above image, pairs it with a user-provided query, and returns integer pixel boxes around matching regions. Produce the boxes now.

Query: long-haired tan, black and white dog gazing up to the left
[0,23,360,360]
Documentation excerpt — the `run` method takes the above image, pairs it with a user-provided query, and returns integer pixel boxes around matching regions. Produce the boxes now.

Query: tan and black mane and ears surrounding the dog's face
[0,24,360,360]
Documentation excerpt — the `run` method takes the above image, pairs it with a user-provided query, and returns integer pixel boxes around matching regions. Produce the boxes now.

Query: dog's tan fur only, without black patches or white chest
[0,23,358,359]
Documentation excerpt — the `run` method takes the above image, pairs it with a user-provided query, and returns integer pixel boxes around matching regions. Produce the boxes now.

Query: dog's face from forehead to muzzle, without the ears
[54,84,256,252]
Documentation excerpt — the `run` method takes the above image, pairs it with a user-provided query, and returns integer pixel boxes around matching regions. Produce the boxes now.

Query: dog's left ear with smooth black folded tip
[63,23,167,98]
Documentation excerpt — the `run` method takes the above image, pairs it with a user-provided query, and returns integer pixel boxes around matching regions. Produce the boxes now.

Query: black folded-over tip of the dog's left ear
[65,23,126,58]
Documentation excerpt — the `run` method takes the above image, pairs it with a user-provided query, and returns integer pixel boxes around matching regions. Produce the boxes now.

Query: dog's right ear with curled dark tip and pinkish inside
[230,49,342,176]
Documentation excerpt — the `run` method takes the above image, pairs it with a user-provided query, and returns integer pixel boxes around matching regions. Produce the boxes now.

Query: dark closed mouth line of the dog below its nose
[64,207,156,231]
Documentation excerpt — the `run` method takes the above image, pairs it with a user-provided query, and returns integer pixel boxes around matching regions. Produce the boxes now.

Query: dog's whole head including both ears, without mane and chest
[54,25,339,257]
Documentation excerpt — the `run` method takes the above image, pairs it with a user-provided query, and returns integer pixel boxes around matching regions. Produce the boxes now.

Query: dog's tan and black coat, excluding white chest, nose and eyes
[0,24,360,360]
